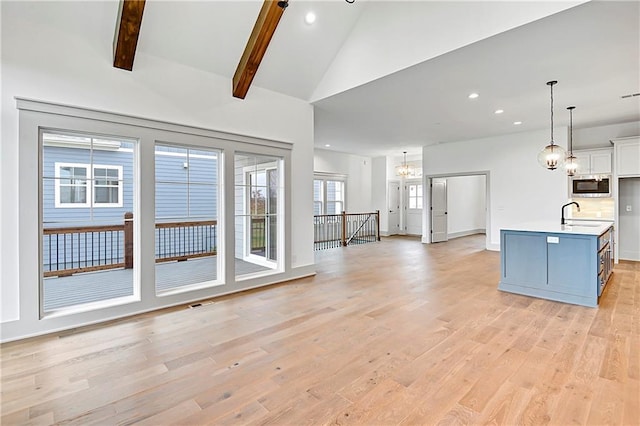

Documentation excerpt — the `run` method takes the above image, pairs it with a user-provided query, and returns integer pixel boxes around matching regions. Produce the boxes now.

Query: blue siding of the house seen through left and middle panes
[42,146,218,271]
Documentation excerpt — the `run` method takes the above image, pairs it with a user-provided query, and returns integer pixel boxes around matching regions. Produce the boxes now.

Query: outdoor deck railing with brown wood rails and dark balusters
[42,213,218,277]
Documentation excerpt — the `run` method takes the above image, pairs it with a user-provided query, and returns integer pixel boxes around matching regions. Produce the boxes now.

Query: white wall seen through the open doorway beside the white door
[447,175,487,238]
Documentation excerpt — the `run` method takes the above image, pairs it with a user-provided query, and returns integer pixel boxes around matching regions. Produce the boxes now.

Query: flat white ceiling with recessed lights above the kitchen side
[314,1,640,155]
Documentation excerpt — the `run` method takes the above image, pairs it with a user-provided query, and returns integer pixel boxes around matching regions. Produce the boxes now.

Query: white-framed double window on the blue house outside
[55,163,122,208]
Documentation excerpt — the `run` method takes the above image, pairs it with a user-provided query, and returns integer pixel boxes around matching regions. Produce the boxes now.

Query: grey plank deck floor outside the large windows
[44,256,267,311]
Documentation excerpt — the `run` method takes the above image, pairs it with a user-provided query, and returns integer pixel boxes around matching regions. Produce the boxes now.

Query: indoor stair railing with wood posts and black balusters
[313,211,380,250]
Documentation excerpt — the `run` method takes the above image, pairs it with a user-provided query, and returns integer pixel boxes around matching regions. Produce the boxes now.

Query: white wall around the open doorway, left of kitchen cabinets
[422,128,567,250]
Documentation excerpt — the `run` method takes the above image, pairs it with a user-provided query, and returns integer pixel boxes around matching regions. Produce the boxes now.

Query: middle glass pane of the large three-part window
[155,145,224,295]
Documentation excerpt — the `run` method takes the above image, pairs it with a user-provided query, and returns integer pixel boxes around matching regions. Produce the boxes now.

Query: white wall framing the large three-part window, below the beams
[0,2,314,330]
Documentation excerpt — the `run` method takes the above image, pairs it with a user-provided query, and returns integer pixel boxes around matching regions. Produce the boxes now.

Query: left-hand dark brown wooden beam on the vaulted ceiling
[113,0,145,71]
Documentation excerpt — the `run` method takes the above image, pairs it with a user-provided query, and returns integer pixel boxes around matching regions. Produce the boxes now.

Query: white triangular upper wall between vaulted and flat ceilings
[311,0,585,102]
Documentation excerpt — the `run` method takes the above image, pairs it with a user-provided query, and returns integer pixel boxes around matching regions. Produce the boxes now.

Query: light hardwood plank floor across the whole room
[1,236,640,425]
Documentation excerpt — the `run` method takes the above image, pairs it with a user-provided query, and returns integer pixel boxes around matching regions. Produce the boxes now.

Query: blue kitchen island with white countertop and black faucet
[498,222,613,307]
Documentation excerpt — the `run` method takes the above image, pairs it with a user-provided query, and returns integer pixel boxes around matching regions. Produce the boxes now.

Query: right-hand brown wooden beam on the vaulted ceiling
[233,0,288,99]
